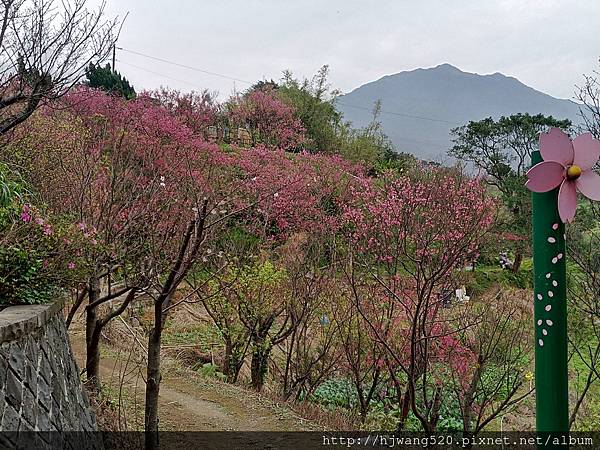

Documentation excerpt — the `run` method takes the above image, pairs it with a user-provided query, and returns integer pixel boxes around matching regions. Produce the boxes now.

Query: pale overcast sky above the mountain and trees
[101,0,600,98]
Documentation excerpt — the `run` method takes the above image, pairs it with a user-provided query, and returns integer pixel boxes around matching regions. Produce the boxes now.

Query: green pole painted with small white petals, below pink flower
[531,151,569,435]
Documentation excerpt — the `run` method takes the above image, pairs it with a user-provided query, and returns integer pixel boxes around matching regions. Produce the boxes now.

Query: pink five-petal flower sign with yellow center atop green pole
[525,128,600,223]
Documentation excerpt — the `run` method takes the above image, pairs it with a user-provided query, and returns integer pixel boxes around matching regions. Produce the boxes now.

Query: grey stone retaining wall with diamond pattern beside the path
[0,304,96,446]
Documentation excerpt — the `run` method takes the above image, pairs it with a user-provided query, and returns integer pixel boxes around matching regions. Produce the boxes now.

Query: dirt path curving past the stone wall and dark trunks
[70,330,315,431]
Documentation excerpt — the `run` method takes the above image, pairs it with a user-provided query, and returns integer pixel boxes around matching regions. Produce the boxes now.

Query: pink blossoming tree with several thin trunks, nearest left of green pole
[344,169,494,432]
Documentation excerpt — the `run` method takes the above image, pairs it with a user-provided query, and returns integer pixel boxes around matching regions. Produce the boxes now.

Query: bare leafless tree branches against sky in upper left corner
[0,0,117,135]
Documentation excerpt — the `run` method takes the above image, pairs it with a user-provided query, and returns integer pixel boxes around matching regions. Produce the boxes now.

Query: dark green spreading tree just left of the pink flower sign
[448,113,571,272]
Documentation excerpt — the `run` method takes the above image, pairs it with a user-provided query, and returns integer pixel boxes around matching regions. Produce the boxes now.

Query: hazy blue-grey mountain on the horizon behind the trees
[337,64,580,161]
